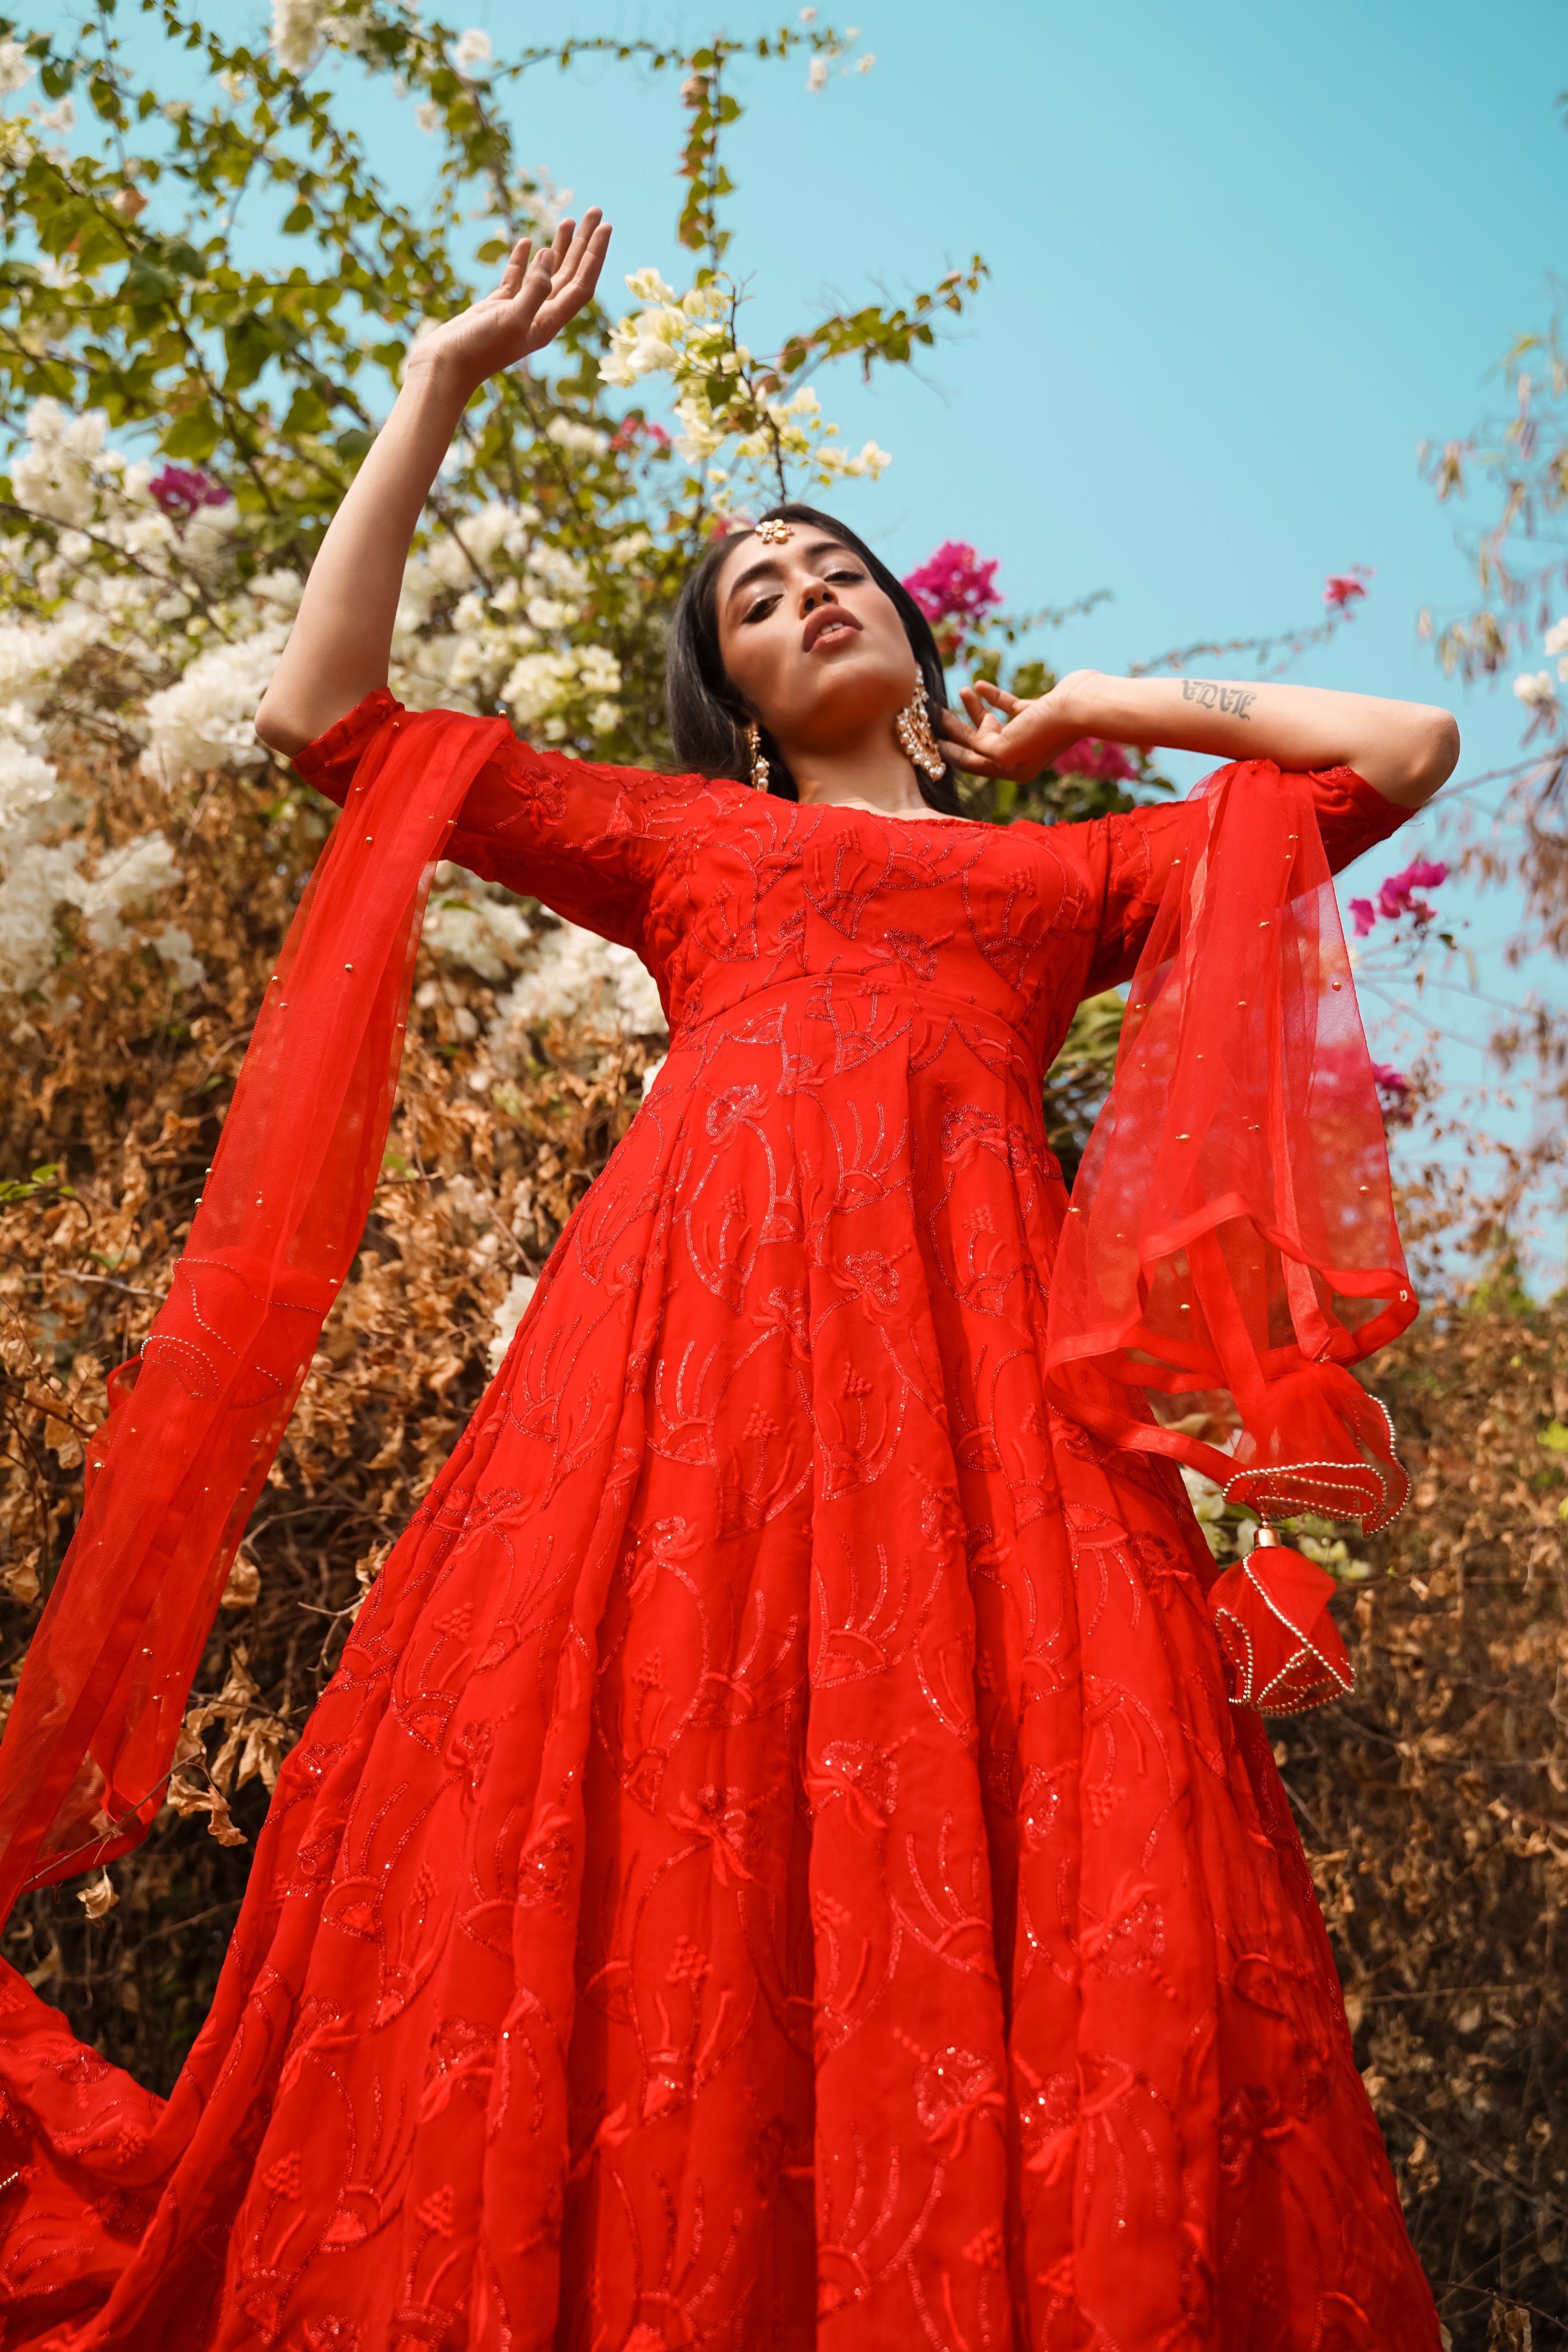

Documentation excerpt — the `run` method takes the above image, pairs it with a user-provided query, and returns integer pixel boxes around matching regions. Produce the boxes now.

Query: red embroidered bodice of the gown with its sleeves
[296,694,1408,1091]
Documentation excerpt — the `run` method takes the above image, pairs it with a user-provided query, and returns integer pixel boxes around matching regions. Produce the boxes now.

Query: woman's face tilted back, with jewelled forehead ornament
[715,522,917,766]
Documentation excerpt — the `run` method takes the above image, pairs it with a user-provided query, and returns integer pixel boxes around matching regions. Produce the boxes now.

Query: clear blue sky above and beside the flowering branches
[76,0,1568,1270]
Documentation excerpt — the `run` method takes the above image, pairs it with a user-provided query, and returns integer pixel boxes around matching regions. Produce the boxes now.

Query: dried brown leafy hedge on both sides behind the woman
[0,743,1568,2347]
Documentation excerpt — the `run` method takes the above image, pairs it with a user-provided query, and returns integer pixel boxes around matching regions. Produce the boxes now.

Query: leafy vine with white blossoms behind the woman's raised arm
[0,0,983,995]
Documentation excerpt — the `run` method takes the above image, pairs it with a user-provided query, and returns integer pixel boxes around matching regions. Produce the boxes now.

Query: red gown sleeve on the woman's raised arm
[294,689,708,948]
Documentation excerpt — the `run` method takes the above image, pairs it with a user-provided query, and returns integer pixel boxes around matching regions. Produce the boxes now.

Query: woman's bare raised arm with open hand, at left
[256,212,609,757]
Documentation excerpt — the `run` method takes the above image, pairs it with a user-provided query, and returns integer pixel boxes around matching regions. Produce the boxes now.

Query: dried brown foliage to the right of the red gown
[1279,1306,1568,2345]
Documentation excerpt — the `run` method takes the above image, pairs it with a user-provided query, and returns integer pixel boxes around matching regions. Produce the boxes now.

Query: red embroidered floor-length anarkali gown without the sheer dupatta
[0,696,1436,2352]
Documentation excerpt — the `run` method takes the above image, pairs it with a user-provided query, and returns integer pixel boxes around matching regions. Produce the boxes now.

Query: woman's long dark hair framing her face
[665,506,964,816]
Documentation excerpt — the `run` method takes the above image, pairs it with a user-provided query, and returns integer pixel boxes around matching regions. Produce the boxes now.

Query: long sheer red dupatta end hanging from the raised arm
[0,696,510,1915]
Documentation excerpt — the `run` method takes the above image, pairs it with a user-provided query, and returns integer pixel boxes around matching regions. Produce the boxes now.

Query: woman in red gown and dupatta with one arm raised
[0,214,1458,2352]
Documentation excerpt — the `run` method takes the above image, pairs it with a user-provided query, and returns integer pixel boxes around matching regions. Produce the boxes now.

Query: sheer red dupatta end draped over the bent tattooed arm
[1046,760,1415,1531]
